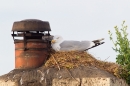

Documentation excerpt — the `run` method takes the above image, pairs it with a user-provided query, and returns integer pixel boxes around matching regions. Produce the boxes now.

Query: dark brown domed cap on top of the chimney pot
[12,19,51,32]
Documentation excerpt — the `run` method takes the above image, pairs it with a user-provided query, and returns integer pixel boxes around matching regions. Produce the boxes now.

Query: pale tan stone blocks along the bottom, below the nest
[52,78,128,86]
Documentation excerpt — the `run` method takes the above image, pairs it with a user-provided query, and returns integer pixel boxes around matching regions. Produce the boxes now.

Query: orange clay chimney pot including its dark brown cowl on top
[12,19,51,69]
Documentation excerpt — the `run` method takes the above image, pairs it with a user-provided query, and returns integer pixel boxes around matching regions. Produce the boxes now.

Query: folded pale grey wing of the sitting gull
[60,41,95,51]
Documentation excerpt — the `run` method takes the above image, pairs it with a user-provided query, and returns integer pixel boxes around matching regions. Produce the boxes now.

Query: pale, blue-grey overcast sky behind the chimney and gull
[0,0,130,75]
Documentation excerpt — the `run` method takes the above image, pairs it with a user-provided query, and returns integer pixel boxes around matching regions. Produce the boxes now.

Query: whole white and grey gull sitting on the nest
[51,35,103,51]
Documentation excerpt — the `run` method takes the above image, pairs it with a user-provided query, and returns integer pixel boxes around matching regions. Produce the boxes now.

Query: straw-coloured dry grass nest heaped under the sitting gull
[45,51,120,77]
